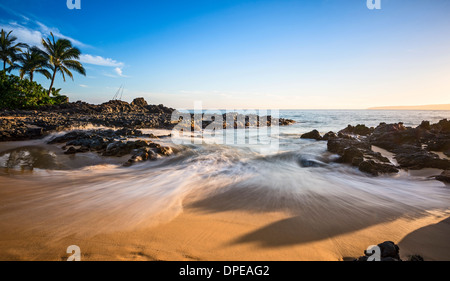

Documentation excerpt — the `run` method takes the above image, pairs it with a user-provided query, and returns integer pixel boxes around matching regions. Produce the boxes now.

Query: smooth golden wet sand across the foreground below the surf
[0,173,450,261]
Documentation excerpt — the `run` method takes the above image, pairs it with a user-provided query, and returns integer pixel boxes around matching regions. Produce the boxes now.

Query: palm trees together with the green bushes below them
[0,29,86,109]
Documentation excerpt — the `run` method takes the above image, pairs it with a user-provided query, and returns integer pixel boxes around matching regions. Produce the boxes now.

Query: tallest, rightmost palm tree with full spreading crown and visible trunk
[42,33,86,95]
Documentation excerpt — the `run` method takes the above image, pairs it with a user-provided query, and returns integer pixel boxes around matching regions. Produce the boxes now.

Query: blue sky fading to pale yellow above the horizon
[0,0,450,109]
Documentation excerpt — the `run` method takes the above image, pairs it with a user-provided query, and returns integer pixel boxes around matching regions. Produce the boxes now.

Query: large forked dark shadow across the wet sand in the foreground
[186,183,436,247]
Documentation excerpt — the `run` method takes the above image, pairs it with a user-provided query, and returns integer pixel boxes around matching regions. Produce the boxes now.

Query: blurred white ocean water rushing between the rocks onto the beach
[0,110,450,238]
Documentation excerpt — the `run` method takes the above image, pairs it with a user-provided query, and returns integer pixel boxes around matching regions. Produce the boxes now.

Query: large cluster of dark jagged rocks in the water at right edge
[302,119,450,178]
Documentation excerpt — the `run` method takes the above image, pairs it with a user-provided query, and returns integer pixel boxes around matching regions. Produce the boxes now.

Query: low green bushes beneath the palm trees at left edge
[0,71,68,109]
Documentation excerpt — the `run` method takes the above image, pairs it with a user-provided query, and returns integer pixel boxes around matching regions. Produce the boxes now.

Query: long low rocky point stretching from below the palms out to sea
[0,98,294,141]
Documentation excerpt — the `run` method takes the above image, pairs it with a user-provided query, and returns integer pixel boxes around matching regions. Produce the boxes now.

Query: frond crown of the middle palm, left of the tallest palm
[13,47,52,82]
